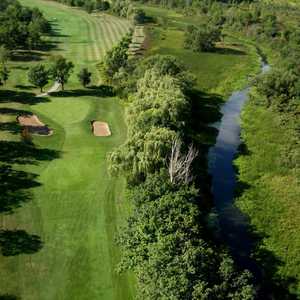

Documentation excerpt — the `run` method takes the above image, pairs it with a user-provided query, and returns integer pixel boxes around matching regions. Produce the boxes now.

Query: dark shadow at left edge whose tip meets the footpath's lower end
[0,90,50,105]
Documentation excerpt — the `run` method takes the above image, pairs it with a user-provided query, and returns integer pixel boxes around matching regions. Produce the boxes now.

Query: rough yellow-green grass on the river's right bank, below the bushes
[235,103,300,299]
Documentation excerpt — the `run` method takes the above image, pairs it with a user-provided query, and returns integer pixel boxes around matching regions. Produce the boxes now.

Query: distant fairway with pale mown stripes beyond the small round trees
[10,0,131,87]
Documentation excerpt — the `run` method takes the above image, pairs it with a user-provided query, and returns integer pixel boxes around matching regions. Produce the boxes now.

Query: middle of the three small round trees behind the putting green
[50,55,74,90]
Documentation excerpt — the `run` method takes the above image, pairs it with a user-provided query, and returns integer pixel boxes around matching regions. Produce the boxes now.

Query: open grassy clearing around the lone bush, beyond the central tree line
[141,6,259,97]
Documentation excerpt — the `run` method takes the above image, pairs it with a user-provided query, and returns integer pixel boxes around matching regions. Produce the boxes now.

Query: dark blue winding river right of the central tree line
[208,61,270,274]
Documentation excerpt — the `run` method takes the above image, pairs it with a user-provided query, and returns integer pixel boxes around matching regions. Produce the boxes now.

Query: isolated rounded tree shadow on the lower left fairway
[0,230,43,256]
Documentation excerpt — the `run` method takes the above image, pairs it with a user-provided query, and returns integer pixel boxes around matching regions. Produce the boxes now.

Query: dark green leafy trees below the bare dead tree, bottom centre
[119,173,254,300]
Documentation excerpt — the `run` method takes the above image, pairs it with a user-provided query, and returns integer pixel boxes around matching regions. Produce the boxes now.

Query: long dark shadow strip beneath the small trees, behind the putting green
[51,85,115,97]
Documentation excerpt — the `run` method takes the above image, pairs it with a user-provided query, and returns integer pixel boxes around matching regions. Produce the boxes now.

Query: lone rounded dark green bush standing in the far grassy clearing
[184,25,221,52]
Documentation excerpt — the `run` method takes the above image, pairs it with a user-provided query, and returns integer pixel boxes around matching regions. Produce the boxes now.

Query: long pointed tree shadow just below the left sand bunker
[0,141,60,164]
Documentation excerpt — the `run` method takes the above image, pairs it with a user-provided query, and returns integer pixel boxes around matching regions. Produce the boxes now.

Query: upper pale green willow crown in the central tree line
[128,69,189,132]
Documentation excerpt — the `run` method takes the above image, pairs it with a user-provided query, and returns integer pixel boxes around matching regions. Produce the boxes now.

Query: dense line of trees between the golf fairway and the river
[100,38,255,300]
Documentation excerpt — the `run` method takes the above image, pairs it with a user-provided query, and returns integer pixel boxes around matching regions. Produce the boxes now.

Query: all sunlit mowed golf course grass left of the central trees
[0,0,134,300]
